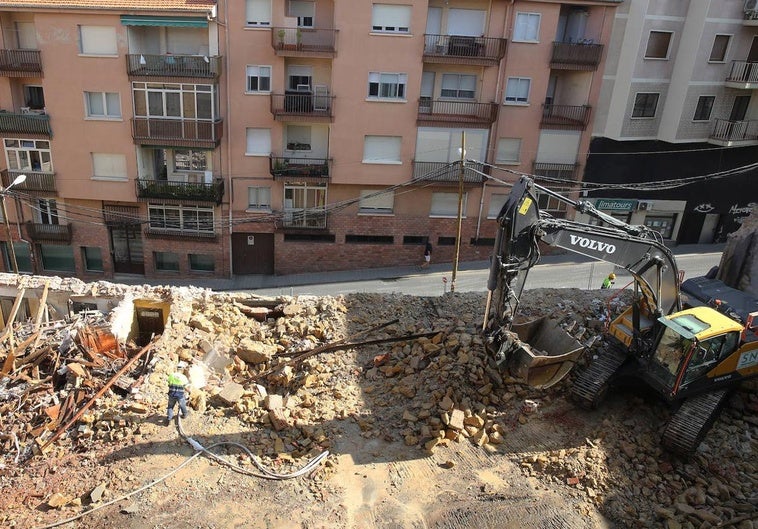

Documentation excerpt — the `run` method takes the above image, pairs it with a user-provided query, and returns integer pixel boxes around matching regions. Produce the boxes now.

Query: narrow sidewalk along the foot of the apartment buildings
[113,243,724,291]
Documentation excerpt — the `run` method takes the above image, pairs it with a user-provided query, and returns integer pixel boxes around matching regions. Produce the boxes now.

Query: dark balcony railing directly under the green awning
[126,53,221,79]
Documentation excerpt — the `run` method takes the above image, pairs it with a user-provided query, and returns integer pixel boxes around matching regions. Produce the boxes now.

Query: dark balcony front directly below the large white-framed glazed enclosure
[132,117,224,149]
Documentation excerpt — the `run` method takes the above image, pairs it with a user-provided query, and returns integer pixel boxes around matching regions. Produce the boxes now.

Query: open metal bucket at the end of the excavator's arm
[501,316,584,388]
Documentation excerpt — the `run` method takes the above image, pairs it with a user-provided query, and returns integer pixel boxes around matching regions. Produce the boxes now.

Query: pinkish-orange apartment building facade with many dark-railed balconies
[0,0,618,279]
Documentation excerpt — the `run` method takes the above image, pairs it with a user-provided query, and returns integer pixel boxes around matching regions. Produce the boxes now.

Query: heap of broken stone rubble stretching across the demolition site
[0,278,758,529]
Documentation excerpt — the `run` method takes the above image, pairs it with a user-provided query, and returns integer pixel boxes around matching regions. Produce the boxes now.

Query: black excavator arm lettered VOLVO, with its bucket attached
[483,177,681,387]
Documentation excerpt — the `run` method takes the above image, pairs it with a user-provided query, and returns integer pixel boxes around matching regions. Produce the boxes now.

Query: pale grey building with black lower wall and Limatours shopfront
[584,0,758,243]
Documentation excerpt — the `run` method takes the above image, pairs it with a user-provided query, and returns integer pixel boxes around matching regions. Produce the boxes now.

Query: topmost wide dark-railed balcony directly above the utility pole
[424,33,507,66]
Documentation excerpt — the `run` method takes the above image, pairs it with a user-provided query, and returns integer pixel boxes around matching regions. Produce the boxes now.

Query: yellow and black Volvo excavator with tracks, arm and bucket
[482,176,758,456]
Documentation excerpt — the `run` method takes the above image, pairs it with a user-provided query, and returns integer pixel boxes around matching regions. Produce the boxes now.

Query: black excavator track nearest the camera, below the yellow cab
[661,389,729,456]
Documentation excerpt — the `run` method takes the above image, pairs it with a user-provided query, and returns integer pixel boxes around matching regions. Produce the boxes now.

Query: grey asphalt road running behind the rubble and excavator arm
[252,251,721,296]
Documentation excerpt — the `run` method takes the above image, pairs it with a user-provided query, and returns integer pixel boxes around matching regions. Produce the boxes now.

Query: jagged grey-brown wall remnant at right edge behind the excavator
[716,207,758,296]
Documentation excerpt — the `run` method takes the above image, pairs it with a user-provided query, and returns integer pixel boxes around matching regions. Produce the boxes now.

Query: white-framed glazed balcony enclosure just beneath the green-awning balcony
[132,82,219,121]
